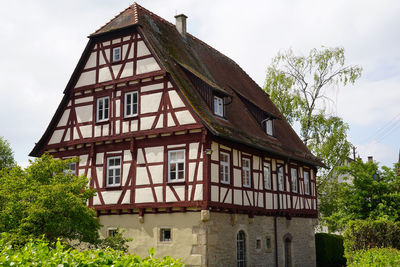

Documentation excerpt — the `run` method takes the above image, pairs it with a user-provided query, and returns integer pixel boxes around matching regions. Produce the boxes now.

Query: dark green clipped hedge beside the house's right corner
[315,233,346,267]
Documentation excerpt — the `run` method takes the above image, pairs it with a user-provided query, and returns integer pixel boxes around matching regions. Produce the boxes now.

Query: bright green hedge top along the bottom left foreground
[0,236,183,267]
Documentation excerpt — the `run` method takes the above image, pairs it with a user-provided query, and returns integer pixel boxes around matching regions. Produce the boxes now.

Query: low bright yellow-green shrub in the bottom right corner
[348,248,400,267]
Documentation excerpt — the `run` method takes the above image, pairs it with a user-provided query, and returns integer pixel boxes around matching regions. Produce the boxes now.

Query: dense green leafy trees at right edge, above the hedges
[326,159,400,231]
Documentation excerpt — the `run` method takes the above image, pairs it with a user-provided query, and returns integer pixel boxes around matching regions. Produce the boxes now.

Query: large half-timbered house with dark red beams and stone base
[30,3,321,266]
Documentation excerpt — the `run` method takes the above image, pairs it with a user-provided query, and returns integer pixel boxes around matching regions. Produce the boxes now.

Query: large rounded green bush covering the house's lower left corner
[0,154,100,247]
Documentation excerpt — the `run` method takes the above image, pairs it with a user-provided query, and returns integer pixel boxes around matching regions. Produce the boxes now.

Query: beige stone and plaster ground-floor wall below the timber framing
[100,211,316,267]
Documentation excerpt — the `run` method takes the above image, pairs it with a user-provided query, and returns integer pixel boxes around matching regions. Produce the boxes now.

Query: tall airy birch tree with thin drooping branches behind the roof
[264,47,362,228]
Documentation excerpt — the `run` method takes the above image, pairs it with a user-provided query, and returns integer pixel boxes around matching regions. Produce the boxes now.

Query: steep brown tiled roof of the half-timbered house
[31,3,323,166]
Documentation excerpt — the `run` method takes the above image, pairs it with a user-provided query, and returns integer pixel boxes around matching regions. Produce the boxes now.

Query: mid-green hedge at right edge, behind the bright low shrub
[343,220,400,257]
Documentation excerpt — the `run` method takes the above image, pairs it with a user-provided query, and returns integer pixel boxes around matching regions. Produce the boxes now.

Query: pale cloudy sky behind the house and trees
[0,0,400,167]
